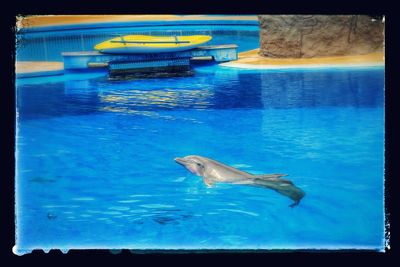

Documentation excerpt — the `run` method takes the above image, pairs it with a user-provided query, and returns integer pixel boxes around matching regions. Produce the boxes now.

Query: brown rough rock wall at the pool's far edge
[258,15,384,58]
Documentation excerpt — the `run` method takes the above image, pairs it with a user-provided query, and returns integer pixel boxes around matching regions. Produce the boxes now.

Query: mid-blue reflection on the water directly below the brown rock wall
[261,70,384,108]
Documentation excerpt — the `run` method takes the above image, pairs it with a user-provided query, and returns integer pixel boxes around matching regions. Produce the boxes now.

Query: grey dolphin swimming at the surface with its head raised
[175,155,305,207]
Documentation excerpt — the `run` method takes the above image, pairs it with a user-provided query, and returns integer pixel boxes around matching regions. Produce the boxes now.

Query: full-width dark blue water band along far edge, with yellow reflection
[17,66,384,119]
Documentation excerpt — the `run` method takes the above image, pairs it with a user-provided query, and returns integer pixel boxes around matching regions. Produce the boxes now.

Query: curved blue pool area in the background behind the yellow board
[16,24,259,61]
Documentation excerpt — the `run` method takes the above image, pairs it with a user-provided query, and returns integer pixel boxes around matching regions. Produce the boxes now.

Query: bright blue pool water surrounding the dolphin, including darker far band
[16,66,384,253]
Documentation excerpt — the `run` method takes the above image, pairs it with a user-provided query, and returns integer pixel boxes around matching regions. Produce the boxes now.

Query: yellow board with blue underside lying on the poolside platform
[94,35,212,54]
